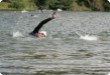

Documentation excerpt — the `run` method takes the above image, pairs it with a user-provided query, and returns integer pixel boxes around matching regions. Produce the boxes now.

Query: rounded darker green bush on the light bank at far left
[9,0,25,9]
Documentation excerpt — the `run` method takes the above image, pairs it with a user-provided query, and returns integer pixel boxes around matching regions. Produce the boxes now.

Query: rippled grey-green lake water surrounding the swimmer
[0,11,110,75]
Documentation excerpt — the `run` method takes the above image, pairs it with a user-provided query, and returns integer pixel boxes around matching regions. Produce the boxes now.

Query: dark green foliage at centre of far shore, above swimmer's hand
[35,0,74,10]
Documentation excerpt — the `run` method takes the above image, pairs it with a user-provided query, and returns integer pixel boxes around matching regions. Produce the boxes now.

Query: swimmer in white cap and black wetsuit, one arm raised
[30,12,57,37]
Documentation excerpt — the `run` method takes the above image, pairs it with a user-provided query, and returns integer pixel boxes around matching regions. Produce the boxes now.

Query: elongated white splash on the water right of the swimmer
[75,32,98,41]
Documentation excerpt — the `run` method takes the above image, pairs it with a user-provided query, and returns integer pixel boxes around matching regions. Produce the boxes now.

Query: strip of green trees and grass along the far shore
[3,0,110,11]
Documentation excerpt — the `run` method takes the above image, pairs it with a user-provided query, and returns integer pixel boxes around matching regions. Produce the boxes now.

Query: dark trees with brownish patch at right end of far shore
[77,0,110,11]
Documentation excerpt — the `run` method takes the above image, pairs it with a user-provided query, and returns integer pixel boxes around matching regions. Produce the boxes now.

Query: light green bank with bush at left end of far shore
[0,0,37,11]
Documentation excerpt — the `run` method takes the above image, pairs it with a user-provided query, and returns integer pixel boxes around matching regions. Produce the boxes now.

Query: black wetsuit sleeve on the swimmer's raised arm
[30,18,52,35]
